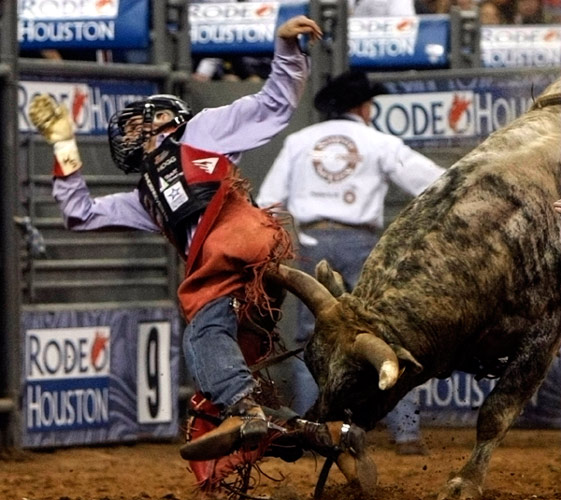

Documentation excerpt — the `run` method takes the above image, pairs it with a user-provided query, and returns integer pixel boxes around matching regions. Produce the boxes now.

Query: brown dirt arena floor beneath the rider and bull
[0,429,561,500]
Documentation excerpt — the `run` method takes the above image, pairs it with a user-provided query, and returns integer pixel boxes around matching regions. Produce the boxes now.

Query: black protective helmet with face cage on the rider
[107,94,193,174]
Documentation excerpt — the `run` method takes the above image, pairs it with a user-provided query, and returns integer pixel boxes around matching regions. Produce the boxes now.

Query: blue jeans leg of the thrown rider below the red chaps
[183,296,256,408]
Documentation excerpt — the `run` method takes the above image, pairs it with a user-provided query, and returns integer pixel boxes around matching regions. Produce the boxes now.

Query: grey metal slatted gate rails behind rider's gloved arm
[20,135,179,309]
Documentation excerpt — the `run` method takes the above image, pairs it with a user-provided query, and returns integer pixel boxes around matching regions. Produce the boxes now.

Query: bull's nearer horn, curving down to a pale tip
[353,333,399,391]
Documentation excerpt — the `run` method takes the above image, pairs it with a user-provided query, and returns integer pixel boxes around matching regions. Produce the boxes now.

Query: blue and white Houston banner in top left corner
[18,0,150,49]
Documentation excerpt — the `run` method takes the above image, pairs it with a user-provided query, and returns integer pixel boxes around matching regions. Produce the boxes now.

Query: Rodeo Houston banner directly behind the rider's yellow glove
[18,75,158,135]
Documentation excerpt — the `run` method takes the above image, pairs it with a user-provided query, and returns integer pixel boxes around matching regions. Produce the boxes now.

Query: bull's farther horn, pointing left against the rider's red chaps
[266,264,337,317]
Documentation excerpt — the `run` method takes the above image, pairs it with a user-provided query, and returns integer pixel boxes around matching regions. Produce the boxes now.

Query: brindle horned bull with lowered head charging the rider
[266,76,561,500]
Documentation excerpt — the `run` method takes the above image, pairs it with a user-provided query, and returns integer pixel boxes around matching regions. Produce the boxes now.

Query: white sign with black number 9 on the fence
[136,322,172,424]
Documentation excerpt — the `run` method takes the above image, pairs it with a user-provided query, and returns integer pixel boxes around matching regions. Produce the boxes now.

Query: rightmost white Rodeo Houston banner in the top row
[481,26,561,68]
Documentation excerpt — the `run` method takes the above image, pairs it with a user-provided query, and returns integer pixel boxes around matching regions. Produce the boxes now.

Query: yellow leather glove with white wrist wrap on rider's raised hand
[29,94,82,177]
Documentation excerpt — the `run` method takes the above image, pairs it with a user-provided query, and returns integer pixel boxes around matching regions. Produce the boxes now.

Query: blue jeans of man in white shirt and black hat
[290,228,420,443]
